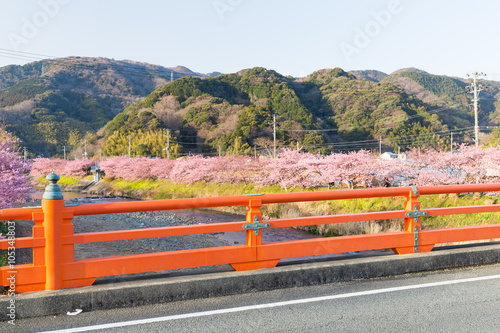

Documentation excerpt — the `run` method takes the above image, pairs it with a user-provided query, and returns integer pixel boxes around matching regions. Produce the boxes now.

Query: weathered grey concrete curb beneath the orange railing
[0,243,500,320]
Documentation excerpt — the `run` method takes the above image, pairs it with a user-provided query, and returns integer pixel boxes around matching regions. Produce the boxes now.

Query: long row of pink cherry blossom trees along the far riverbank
[31,146,500,190]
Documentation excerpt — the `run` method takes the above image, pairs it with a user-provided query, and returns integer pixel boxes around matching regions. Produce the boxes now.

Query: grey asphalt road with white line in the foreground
[0,264,500,333]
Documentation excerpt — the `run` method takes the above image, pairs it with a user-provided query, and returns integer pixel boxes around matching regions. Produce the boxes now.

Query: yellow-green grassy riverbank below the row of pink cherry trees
[40,177,500,236]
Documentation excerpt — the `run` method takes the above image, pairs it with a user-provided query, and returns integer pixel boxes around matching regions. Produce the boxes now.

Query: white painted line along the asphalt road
[41,275,500,333]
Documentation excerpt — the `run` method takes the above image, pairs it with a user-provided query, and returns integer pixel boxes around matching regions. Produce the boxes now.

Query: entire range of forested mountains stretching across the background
[0,57,500,157]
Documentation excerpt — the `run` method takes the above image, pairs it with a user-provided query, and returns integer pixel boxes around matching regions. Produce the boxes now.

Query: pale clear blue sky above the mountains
[0,0,500,80]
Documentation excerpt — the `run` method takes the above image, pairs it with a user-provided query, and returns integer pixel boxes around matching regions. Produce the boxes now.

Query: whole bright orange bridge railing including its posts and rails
[0,174,500,292]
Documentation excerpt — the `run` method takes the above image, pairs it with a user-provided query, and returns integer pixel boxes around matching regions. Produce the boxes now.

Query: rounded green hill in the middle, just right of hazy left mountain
[103,68,324,155]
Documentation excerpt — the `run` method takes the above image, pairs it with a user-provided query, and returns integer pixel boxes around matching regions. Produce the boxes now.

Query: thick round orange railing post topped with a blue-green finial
[42,172,64,290]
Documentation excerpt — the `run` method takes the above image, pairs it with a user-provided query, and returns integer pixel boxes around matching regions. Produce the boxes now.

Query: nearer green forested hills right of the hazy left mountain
[103,68,496,155]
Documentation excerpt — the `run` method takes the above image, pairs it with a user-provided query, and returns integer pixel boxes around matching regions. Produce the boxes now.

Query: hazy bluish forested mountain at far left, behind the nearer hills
[0,57,206,155]
